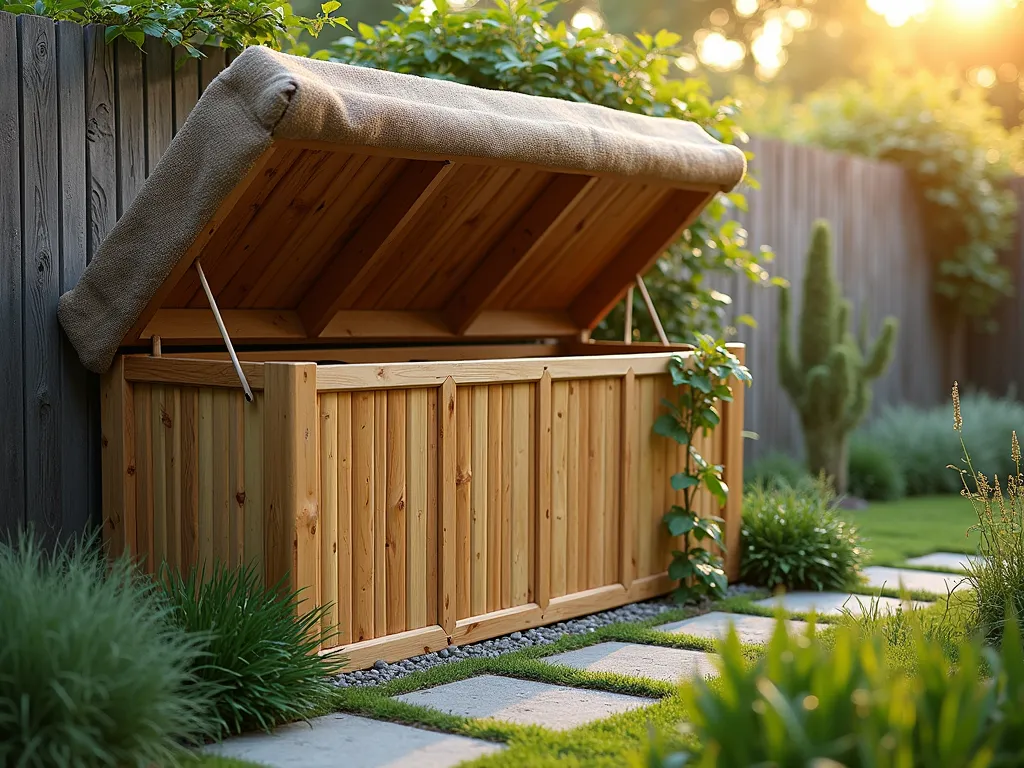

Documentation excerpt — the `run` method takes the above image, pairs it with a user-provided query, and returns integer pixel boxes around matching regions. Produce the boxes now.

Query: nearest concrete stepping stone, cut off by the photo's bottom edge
[203,714,505,768]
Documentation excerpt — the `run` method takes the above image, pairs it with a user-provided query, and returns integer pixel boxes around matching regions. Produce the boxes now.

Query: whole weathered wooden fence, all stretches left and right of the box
[0,13,1011,536]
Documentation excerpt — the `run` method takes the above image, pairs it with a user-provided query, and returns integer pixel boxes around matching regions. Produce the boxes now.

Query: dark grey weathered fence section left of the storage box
[0,12,226,538]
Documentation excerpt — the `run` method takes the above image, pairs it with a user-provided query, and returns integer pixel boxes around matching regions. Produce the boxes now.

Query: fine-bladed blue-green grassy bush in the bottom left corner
[0,535,208,768]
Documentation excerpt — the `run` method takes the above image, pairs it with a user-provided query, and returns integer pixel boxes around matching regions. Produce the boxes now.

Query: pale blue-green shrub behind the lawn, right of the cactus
[859,394,1024,496]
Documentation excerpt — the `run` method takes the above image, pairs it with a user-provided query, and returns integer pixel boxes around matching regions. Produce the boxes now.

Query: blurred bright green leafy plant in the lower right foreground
[646,610,1024,768]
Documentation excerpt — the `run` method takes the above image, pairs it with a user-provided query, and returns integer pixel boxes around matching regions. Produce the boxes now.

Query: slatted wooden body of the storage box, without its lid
[103,344,743,668]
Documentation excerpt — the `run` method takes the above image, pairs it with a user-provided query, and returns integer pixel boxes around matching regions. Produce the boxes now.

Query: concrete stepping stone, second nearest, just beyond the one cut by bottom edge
[396,675,656,731]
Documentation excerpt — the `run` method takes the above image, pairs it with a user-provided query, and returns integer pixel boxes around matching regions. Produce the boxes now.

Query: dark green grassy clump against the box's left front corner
[161,564,344,738]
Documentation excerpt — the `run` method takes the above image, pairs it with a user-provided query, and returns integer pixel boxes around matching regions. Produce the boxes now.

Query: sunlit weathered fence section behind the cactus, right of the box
[721,139,948,460]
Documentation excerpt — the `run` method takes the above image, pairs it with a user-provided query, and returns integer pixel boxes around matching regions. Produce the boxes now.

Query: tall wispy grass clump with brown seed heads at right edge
[951,384,1024,642]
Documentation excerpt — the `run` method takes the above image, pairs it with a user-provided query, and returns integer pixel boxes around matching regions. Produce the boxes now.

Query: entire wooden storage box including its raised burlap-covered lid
[59,47,744,667]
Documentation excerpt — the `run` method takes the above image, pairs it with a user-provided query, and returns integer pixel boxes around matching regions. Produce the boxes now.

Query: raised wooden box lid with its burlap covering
[60,51,744,370]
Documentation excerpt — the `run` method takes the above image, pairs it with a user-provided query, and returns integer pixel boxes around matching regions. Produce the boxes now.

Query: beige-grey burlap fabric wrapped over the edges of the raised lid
[58,47,745,373]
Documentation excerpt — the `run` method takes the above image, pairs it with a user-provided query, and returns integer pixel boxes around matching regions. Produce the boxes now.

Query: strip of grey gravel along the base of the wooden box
[333,584,758,688]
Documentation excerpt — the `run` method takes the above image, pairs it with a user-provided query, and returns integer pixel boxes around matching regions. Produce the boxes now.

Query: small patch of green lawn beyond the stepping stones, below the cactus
[846,496,978,565]
